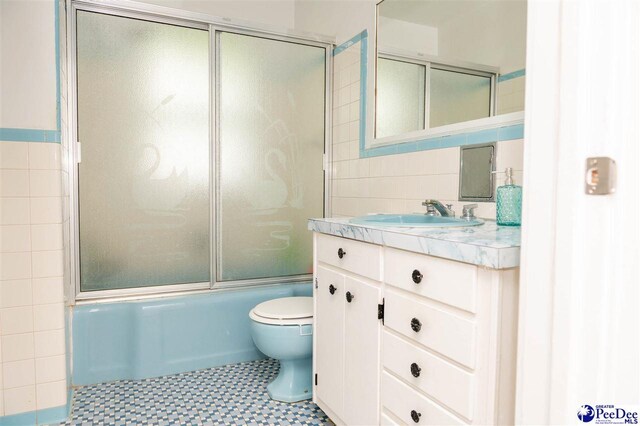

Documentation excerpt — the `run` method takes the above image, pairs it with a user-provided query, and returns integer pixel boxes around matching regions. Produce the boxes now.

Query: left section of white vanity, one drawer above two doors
[314,234,382,425]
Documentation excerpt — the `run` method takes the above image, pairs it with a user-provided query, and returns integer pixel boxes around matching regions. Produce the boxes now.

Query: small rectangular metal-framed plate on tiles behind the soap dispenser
[458,143,496,201]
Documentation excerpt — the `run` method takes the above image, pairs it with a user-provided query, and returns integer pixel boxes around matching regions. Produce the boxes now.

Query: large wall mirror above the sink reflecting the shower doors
[375,0,527,139]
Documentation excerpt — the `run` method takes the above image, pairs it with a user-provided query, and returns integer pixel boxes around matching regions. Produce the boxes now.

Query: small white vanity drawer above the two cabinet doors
[316,234,381,281]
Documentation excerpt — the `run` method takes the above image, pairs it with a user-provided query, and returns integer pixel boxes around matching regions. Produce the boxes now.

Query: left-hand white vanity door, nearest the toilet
[314,266,345,417]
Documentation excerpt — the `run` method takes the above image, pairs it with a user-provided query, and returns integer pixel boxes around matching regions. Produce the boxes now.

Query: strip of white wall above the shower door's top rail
[139,0,295,29]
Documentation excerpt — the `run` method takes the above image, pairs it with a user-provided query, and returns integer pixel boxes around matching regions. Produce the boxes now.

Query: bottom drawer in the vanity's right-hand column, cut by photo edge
[381,372,465,425]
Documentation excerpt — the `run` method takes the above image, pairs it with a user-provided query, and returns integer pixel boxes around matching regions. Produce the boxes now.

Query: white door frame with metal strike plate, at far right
[515,0,640,424]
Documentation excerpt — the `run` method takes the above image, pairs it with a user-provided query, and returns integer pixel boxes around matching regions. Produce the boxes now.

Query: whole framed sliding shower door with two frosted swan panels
[70,2,332,299]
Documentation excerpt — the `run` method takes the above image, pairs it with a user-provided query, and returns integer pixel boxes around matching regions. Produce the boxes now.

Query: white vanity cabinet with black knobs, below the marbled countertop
[314,232,518,425]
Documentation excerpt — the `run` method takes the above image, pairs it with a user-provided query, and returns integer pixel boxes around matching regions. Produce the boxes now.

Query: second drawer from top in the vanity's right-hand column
[384,289,476,368]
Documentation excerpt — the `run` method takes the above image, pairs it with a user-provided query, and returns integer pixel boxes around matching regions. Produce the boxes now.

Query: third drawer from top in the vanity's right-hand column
[382,331,473,420]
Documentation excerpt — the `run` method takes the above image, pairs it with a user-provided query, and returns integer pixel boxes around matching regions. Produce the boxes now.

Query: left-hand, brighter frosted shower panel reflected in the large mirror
[376,58,426,138]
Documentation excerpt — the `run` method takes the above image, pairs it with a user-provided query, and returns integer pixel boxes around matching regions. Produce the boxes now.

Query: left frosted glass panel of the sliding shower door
[77,12,210,291]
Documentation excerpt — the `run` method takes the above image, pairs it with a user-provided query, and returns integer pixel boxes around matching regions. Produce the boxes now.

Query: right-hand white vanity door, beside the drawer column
[342,277,381,425]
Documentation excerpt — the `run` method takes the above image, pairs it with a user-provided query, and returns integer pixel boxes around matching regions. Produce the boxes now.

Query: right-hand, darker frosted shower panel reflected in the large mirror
[429,68,491,127]
